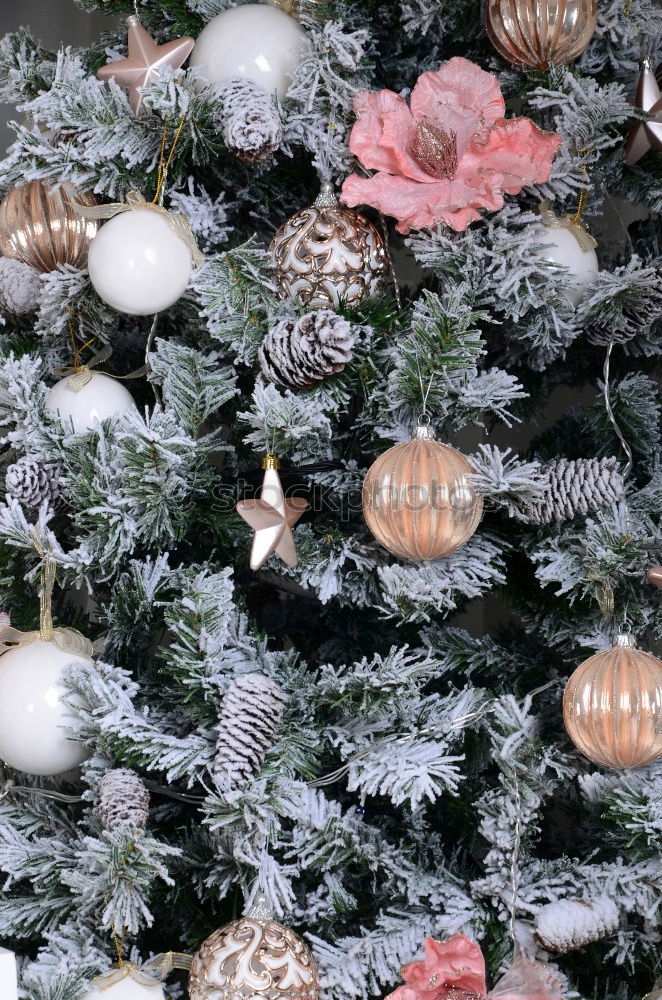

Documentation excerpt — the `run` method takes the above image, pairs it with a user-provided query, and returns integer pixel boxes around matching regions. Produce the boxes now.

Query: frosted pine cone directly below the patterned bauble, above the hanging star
[259,309,356,389]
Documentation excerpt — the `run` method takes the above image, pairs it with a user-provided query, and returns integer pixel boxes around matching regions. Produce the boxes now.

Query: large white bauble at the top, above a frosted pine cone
[191,3,308,101]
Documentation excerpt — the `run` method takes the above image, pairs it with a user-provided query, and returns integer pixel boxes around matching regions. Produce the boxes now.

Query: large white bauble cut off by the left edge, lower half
[0,639,90,775]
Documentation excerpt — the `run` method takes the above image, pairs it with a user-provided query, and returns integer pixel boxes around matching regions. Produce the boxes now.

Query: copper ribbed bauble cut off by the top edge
[485,0,598,69]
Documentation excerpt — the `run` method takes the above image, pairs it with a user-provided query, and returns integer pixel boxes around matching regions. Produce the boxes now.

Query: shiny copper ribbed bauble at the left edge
[0,181,99,273]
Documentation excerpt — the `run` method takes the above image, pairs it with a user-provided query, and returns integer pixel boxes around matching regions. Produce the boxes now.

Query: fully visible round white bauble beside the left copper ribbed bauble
[87,208,193,316]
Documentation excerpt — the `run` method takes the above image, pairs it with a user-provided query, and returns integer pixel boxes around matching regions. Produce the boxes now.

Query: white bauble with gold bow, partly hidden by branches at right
[530,201,599,307]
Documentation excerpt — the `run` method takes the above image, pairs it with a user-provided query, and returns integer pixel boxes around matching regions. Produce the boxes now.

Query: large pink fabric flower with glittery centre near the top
[341,56,562,233]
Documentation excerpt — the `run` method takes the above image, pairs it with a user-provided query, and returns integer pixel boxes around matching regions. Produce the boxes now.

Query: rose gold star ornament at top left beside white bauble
[97,14,195,114]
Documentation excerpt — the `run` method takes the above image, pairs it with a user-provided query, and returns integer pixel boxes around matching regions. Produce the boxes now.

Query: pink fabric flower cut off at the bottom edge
[386,934,563,1000]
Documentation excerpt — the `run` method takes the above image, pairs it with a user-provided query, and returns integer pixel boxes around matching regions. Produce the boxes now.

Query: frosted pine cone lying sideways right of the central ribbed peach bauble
[526,458,623,524]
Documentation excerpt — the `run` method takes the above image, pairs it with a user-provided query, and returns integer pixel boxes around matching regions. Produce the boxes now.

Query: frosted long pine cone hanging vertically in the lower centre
[214,672,285,791]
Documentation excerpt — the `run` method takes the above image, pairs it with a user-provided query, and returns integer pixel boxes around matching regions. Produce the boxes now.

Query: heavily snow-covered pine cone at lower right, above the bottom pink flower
[535,896,619,953]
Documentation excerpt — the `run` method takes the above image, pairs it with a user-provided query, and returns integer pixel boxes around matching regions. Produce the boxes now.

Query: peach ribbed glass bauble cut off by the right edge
[563,631,662,769]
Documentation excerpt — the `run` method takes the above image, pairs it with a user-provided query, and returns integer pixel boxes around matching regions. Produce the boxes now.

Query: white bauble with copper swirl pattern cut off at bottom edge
[188,896,319,1000]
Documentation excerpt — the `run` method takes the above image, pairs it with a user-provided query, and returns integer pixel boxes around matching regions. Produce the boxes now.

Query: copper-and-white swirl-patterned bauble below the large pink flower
[270,183,388,309]
